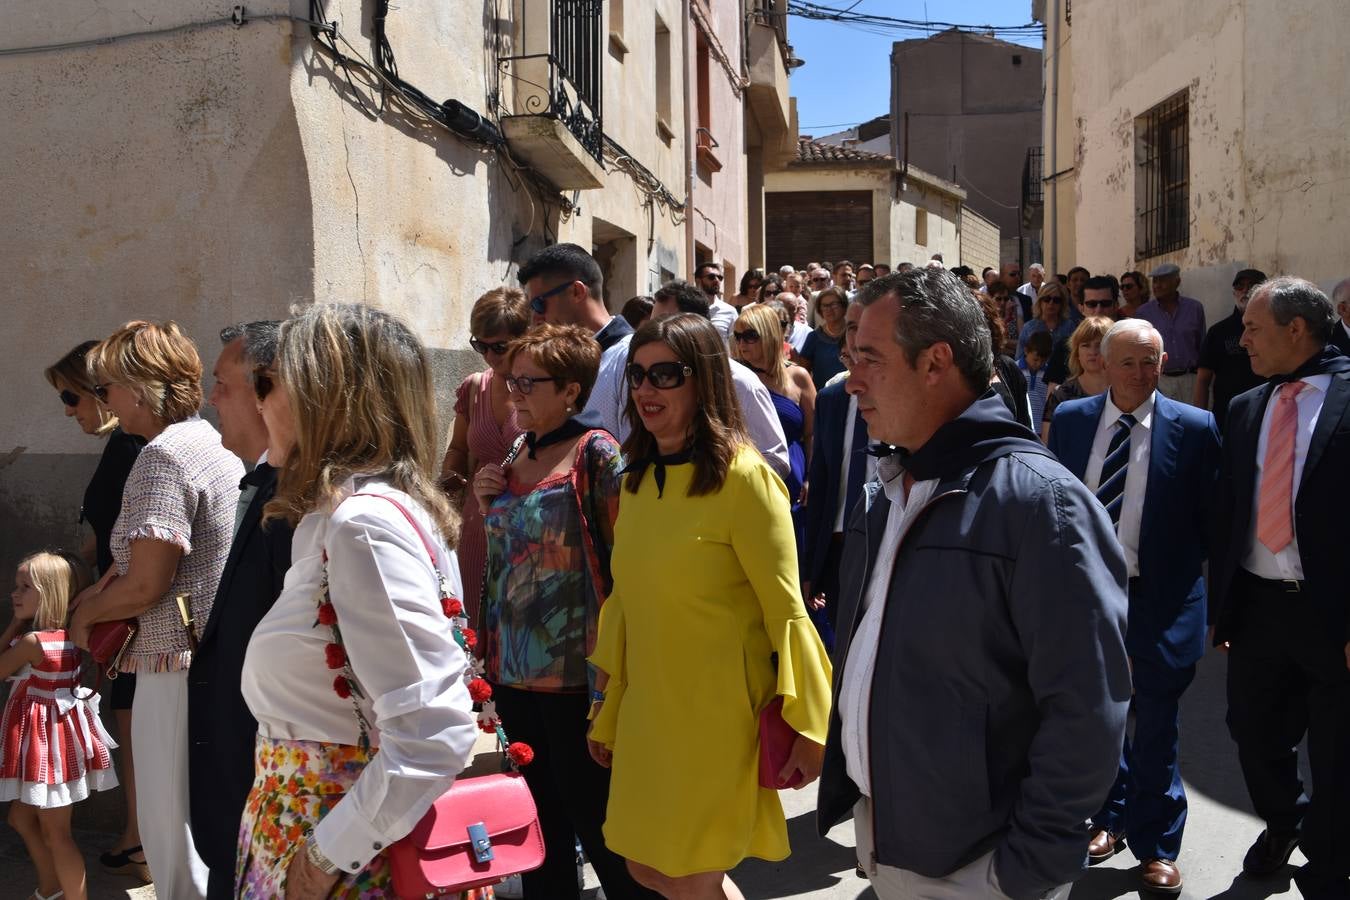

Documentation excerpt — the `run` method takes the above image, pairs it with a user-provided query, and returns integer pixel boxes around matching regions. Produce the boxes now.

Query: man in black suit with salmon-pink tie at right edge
[1210,278,1350,899]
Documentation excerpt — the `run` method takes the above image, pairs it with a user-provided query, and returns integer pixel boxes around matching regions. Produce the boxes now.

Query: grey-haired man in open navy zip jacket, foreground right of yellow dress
[818,269,1130,900]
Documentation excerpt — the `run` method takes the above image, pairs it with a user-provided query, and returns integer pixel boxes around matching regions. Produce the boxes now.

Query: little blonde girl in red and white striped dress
[0,552,117,900]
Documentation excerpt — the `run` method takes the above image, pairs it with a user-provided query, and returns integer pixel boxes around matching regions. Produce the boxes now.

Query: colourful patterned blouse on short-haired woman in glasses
[481,430,624,692]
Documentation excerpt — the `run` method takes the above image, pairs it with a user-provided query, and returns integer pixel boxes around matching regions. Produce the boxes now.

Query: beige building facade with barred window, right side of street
[1044,0,1350,322]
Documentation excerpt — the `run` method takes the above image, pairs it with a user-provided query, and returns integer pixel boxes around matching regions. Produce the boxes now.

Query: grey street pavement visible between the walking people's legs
[0,653,1303,900]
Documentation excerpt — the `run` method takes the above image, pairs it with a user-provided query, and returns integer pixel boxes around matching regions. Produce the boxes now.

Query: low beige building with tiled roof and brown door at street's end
[765,138,999,269]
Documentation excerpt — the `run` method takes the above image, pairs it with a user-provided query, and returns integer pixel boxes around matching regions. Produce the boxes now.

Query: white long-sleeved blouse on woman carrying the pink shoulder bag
[242,478,478,872]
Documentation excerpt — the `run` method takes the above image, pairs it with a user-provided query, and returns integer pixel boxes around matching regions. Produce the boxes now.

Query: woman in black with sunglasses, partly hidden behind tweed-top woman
[43,340,150,881]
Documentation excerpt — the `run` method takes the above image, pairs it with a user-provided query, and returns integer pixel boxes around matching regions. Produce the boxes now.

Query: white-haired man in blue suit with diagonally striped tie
[1049,318,1220,893]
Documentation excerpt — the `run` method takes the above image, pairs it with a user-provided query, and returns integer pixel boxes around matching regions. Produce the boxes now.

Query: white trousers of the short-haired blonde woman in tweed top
[131,669,207,900]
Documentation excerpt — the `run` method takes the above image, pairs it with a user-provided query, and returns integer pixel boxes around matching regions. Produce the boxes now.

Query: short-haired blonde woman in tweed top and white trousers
[70,321,244,900]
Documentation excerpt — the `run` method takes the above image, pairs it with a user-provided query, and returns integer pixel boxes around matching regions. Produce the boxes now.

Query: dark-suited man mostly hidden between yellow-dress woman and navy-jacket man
[802,304,876,644]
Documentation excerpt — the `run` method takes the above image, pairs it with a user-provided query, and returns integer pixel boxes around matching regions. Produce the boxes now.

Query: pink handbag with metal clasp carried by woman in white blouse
[386,775,544,900]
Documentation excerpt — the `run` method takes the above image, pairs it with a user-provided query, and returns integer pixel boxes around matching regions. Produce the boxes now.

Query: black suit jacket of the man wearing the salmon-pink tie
[1210,348,1350,646]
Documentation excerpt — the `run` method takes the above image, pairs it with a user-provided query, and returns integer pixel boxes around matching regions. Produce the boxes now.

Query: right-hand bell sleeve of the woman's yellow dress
[729,449,832,743]
